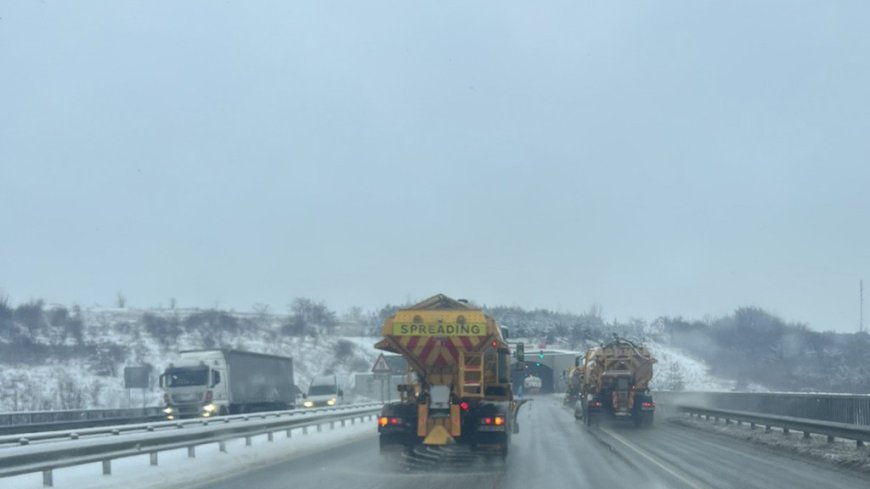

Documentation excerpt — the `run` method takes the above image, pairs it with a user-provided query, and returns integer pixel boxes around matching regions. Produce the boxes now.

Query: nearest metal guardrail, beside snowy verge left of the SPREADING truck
[0,403,381,487]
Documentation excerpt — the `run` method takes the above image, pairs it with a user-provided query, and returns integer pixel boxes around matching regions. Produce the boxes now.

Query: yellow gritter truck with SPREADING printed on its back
[375,294,519,456]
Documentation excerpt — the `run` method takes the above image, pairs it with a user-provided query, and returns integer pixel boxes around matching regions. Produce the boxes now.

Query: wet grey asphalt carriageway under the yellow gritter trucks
[198,397,870,489]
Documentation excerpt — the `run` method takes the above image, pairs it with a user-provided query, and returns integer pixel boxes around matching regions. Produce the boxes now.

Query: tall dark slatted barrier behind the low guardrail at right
[653,391,870,426]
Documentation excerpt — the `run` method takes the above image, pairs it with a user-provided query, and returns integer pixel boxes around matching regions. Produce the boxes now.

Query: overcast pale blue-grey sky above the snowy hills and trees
[0,0,870,331]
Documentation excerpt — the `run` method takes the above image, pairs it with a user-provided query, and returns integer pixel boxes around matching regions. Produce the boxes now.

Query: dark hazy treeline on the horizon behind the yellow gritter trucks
[354,304,870,393]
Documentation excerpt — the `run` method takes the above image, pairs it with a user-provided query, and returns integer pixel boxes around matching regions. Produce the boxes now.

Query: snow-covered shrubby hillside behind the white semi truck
[0,308,377,412]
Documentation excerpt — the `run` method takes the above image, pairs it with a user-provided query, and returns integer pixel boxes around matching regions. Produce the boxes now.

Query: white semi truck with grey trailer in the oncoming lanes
[160,350,298,419]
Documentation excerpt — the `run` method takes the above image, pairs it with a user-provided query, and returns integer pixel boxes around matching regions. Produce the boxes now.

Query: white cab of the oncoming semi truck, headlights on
[160,352,229,420]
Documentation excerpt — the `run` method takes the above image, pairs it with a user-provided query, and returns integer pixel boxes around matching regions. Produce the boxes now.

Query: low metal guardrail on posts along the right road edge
[676,406,870,448]
